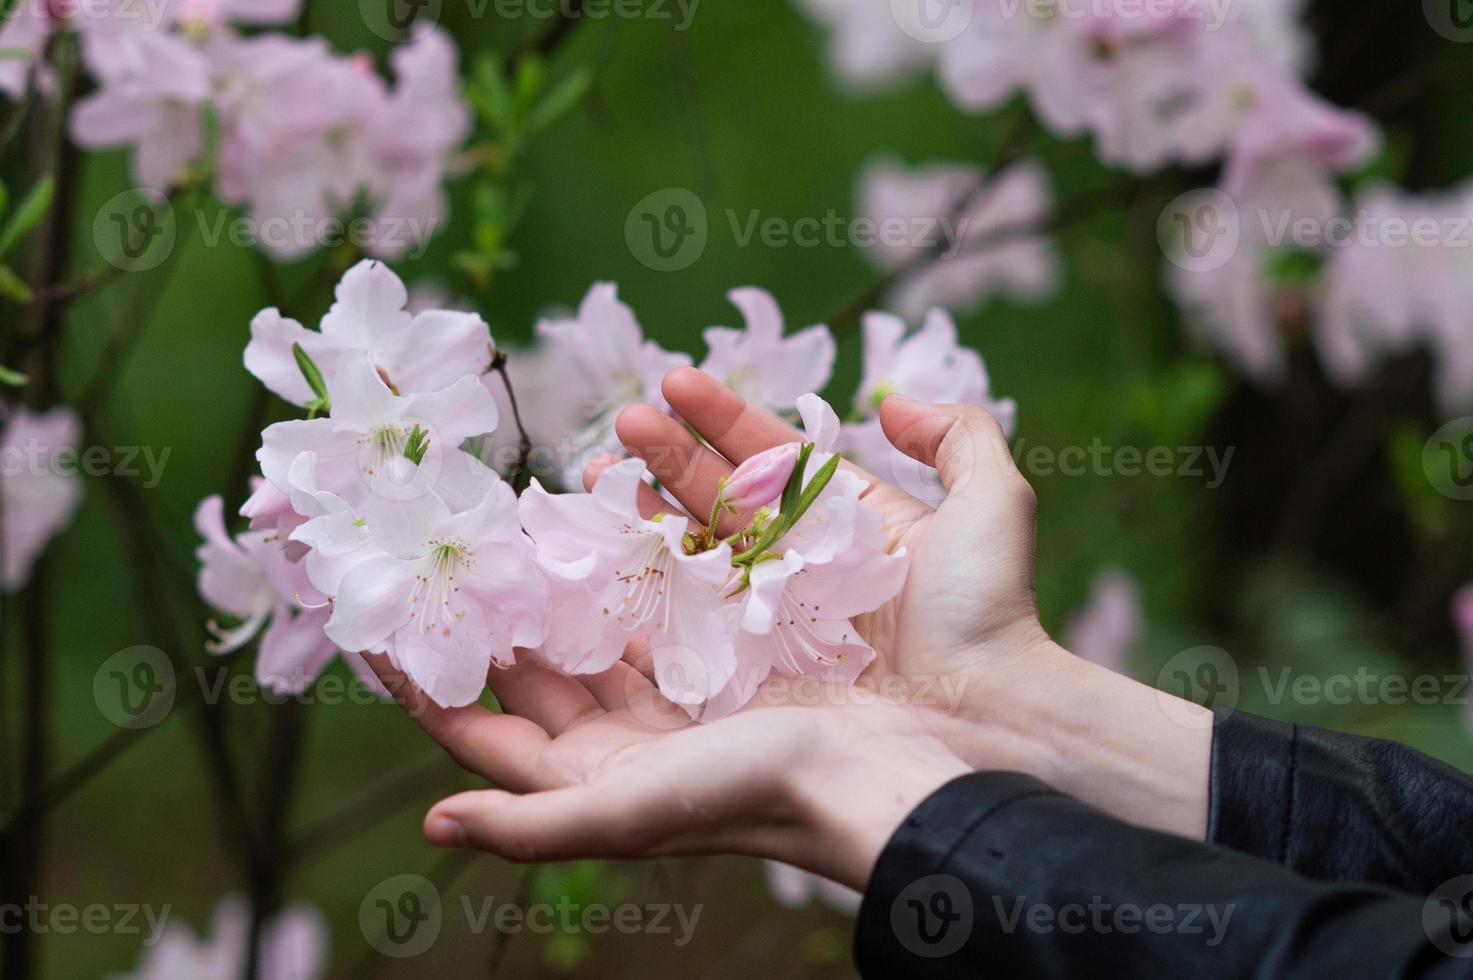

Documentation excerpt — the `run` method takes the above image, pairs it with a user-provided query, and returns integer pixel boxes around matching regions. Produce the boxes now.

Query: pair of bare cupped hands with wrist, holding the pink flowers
[371,368,1211,887]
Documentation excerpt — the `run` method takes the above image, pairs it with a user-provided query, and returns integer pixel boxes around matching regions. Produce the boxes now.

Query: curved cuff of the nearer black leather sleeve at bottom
[854,772,1062,977]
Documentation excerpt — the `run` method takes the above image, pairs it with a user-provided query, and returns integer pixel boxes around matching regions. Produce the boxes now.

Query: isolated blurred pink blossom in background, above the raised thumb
[860,158,1061,319]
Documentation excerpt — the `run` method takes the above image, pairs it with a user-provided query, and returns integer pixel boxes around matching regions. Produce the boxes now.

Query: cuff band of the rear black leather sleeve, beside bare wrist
[1206,712,1299,864]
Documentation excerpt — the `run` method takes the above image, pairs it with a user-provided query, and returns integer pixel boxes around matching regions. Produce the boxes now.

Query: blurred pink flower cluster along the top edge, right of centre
[801,0,1331,172]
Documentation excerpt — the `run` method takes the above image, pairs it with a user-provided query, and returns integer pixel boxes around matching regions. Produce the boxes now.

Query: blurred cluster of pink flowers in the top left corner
[0,0,471,258]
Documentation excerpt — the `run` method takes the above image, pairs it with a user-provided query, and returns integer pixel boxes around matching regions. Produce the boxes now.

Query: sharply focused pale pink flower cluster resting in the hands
[196,261,1013,710]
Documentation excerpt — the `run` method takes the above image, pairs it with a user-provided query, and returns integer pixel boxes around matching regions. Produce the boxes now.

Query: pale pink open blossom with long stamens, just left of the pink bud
[520,460,737,704]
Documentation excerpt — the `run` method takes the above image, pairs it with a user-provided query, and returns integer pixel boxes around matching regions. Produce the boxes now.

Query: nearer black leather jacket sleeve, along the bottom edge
[854,763,1473,980]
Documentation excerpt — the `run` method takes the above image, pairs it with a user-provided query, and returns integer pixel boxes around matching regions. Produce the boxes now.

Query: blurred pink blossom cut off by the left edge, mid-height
[0,408,82,592]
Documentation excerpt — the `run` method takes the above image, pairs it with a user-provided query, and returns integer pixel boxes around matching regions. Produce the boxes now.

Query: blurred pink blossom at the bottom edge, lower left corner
[110,896,328,980]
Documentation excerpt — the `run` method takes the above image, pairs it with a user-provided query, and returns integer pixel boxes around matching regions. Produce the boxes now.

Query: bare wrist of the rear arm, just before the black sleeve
[947,637,1212,839]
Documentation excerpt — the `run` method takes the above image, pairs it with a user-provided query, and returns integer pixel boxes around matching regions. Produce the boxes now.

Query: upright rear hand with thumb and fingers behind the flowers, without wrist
[619,368,1041,695]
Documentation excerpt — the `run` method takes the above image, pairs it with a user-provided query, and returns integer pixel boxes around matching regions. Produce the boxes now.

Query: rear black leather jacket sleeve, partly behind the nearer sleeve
[1208,712,1473,895]
